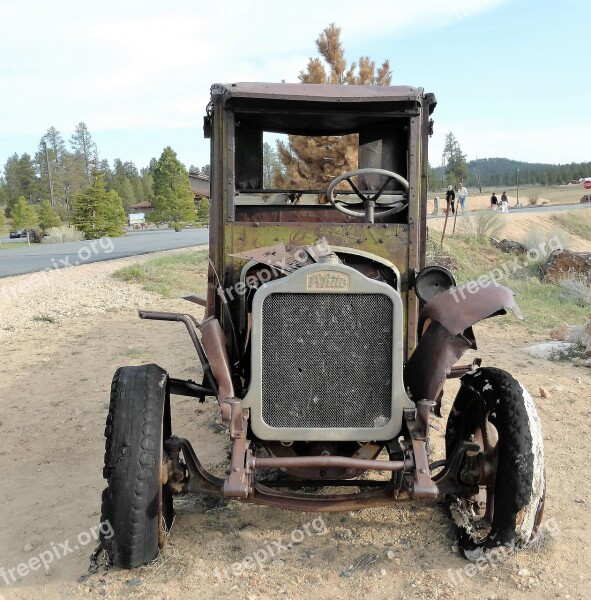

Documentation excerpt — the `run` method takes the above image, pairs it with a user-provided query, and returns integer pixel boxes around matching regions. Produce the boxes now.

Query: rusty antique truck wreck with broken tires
[101,83,545,568]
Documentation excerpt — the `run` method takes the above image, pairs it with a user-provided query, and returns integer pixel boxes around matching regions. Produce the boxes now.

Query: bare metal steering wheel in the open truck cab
[326,168,409,223]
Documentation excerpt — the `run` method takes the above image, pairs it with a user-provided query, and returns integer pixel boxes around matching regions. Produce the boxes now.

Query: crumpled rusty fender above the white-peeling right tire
[404,281,523,414]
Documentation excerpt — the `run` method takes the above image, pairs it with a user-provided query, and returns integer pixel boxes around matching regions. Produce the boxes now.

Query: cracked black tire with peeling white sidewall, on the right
[445,367,546,560]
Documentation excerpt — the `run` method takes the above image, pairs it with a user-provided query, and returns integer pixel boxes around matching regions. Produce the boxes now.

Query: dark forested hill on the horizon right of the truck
[433,158,591,187]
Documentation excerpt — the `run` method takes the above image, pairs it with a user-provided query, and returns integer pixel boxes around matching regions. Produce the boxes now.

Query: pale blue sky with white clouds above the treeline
[0,0,591,173]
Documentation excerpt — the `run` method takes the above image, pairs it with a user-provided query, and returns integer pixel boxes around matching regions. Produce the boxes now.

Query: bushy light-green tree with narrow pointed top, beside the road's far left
[72,170,127,239]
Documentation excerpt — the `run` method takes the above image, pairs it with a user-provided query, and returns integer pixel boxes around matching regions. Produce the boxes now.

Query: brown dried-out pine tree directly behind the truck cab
[274,23,392,188]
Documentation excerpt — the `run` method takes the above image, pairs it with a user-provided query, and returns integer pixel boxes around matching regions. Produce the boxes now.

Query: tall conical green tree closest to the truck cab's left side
[150,146,197,231]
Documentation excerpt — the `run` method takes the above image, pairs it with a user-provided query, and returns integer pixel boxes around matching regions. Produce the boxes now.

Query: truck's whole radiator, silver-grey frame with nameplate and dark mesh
[244,264,414,441]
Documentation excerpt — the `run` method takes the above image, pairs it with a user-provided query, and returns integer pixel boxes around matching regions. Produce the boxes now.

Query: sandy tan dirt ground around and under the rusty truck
[0,250,591,600]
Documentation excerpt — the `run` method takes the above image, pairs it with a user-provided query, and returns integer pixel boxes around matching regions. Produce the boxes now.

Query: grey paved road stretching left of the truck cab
[0,229,209,277]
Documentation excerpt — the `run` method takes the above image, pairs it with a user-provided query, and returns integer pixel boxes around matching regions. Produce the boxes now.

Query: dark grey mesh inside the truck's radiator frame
[262,293,393,428]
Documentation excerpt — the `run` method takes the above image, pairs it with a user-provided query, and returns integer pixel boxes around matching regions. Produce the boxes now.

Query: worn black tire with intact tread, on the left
[101,364,174,569]
